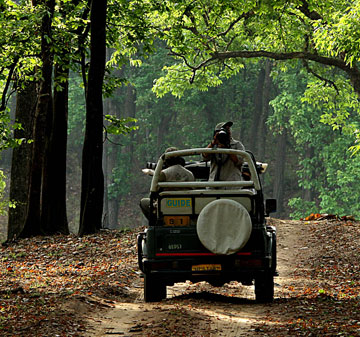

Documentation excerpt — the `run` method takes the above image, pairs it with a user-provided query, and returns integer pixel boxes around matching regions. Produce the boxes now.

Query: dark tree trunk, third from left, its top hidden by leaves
[41,65,69,234]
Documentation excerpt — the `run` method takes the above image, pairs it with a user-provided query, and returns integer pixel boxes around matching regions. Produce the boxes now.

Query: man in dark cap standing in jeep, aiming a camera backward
[202,122,245,181]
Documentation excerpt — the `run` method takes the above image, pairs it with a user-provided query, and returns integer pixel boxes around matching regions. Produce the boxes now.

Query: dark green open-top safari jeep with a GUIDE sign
[138,148,276,302]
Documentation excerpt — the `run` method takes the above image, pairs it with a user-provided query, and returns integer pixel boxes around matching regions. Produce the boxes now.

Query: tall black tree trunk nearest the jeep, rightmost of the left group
[79,0,107,235]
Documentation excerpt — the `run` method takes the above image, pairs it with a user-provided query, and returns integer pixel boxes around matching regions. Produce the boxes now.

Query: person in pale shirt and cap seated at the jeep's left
[140,147,195,219]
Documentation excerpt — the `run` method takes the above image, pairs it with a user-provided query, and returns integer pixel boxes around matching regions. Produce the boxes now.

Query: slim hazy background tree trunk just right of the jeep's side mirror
[274,129,287,217]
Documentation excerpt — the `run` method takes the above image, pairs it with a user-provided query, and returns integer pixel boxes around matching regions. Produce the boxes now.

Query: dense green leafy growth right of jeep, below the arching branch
[268,63,360,218]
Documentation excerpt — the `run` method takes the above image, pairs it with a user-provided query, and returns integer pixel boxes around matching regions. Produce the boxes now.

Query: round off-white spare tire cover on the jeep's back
[196,199,252,255]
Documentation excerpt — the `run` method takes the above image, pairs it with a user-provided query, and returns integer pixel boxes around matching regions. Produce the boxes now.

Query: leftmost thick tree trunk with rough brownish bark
[7,82,37,240]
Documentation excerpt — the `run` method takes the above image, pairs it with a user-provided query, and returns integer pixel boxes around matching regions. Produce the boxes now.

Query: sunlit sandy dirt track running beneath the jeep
[84,220,334,337]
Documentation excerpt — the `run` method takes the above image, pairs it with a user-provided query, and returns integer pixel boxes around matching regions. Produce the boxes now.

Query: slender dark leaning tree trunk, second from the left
[21,0,55,237]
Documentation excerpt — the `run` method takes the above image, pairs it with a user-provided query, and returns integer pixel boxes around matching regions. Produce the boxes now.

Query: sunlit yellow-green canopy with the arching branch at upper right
[146,0,360,175]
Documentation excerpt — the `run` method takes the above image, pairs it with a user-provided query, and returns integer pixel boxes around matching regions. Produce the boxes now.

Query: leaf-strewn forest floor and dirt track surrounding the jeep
[0,219,360,337]
